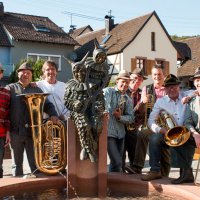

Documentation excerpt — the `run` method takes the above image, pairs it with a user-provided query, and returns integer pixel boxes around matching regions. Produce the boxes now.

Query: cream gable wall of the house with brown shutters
[123,16,177,84]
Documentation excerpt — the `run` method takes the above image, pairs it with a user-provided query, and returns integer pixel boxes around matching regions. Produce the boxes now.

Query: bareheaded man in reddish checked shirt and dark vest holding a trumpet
[131,65,167,176]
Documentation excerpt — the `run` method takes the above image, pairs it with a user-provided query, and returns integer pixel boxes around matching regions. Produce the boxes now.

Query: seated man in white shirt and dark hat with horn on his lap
[142,74,193,183]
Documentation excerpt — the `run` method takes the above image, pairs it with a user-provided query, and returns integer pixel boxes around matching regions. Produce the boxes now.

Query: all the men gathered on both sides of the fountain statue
[0,62,200,184]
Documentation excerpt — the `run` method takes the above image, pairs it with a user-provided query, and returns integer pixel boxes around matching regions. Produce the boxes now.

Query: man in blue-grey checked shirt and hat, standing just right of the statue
[104,70,134,172]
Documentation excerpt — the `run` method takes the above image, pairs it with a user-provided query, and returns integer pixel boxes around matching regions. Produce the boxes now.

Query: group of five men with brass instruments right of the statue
[105,65,200,184]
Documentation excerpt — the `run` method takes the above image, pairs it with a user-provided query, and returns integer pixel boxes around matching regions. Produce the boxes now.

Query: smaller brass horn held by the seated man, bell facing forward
[157,110,190,147]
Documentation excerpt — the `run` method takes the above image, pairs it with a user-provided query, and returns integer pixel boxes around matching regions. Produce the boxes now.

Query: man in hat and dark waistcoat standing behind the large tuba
[6,62,58,176]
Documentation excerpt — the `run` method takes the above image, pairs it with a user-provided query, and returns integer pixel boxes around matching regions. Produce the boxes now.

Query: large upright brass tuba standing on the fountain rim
[20,93,67,175]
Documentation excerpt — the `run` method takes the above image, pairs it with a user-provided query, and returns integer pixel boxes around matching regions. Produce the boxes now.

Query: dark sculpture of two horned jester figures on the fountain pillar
[64,43,109,162]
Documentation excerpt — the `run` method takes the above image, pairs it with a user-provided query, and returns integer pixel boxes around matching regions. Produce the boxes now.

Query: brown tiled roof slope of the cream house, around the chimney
[76,12,155,55]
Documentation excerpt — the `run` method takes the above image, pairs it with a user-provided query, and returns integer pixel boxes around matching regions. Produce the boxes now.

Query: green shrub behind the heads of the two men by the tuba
[10,59,45,83]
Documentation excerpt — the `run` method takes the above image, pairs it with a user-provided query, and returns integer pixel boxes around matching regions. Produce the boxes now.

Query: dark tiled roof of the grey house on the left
[1,12,77,45]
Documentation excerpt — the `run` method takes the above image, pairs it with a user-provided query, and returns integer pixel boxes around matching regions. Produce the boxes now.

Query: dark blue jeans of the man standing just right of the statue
[108,137,124,172]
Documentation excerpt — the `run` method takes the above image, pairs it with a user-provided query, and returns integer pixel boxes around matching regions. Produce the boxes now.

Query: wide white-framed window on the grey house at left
[27,53,61,71]
